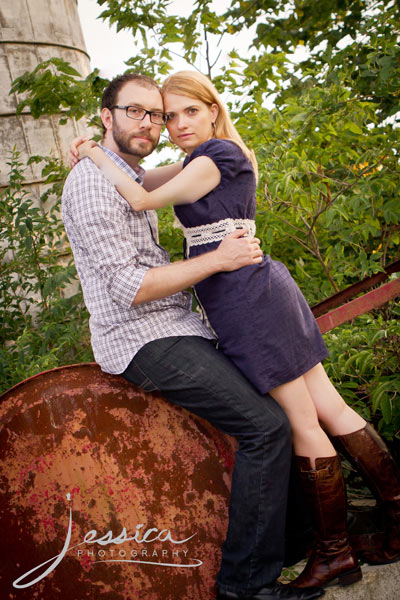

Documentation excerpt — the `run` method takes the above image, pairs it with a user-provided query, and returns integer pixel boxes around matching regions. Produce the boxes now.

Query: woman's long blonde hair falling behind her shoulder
[161,71,258,178]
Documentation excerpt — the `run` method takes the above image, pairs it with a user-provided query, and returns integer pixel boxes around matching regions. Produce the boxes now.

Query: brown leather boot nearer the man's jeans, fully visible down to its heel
[290,456,362,588]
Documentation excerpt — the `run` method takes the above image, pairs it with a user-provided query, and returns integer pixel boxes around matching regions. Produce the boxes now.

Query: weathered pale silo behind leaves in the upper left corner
[0,0,90,197]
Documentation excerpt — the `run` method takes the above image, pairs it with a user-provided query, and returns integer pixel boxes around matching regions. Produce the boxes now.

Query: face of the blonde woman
[164,92,218,155]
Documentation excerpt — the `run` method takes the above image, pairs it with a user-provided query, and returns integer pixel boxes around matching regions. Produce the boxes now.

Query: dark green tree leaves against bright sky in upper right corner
[228,0,400,123]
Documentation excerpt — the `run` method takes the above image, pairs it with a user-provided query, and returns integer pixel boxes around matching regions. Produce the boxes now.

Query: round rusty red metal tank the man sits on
[0,364,235,600]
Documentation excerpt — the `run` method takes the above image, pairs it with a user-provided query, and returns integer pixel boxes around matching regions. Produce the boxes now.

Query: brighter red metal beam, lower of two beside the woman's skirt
[317,279,400,333]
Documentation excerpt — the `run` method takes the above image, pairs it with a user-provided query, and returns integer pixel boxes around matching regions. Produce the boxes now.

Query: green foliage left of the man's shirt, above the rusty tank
[0,151,93,391]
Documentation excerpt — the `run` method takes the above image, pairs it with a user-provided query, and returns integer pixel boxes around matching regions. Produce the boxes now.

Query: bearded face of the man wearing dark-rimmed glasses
[108,81,164,158]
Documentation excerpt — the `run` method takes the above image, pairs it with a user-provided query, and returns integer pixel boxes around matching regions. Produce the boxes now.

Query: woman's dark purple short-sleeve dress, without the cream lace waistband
[175,138,328,394]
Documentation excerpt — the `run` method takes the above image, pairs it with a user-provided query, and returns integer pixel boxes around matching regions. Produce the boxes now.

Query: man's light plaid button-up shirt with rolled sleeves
[62,148,213,374]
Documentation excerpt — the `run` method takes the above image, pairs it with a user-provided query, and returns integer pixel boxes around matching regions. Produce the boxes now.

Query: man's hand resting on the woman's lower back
[215,229,263,271]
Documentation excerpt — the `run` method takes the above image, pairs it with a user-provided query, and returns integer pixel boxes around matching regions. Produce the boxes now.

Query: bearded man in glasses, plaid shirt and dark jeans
[63,75,323,600]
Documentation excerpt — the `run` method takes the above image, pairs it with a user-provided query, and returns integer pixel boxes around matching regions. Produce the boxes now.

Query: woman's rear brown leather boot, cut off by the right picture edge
[333,425,400,565]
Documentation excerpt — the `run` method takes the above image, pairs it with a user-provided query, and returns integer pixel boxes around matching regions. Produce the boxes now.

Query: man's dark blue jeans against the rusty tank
[122,336,291,594]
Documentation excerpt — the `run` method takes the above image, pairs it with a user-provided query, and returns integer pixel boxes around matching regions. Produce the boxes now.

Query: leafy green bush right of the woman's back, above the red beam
[253,85,400,301]
